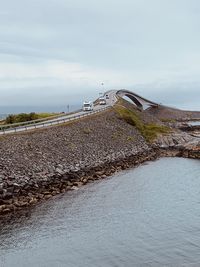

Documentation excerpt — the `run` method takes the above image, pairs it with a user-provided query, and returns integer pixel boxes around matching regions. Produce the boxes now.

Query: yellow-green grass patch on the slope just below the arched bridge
[115,105,170,143]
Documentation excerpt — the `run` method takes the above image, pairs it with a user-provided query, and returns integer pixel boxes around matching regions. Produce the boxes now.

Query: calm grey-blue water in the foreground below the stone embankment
[0,158,200,267]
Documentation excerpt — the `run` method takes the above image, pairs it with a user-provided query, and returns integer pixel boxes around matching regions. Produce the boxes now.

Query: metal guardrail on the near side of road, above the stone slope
[0,106,111,135]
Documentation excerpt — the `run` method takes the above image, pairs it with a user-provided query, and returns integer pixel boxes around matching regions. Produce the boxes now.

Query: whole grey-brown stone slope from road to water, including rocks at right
[0,106,200,214]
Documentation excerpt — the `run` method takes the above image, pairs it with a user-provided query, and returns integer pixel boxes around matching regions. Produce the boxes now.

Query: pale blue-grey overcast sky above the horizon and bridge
[0,0,200,110]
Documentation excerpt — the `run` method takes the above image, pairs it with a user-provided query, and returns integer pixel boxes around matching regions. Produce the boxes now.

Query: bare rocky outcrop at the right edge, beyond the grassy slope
[145,106,200,159]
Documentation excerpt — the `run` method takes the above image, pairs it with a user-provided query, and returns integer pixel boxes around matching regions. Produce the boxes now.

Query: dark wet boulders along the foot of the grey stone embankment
[0,149,160,215]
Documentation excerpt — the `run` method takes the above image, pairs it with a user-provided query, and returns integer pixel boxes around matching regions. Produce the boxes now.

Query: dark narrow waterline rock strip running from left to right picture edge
[0,148,200,217]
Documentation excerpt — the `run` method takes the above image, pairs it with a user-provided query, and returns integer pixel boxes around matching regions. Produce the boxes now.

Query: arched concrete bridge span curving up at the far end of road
[116,89,159,110]
